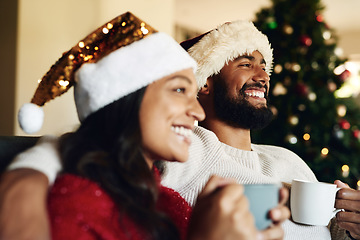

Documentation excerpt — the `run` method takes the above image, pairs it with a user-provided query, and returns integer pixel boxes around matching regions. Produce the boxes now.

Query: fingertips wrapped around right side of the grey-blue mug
[260,188,290,240]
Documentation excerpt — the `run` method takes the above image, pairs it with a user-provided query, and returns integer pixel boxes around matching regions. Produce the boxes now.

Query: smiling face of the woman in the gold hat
[139,69,205,166]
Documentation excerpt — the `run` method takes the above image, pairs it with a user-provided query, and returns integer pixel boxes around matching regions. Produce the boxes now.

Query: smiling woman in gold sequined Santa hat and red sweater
[14,13,255,240]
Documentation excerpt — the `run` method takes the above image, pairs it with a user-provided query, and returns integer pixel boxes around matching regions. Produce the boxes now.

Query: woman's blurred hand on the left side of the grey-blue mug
[188,176,257,240]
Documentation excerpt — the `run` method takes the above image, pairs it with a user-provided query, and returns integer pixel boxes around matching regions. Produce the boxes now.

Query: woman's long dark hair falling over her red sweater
[60,87,179,240]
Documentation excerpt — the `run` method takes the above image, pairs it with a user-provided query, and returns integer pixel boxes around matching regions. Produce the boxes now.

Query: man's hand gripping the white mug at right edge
[335,180,360,239]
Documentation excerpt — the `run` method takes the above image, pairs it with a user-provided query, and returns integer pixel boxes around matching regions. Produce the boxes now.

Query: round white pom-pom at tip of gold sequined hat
[18,103,44,134]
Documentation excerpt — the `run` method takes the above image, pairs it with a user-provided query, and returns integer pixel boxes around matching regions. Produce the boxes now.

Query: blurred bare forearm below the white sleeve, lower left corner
[0,168,50,240]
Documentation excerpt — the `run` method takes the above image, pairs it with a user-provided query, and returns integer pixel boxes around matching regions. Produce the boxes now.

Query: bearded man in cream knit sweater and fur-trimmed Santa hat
[163,21,360,240]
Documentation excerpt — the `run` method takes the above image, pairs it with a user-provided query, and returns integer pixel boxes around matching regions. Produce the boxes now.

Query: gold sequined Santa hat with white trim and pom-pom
[18,12,196,133]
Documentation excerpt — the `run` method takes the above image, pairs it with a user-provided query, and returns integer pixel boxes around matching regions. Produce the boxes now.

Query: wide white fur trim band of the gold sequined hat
[74,32,196,121]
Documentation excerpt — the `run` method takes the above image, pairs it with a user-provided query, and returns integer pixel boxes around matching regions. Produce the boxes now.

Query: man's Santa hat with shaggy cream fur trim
[181,20,273,88]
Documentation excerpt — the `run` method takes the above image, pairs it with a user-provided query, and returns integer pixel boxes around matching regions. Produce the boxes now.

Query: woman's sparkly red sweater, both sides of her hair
[48,174,191,240]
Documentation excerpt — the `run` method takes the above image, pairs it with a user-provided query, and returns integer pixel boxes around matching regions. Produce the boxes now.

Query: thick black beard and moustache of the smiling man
[214,79,273,130]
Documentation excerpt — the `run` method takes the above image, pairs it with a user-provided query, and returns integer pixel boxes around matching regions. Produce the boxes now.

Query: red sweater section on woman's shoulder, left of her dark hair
[48,174,143,239]
